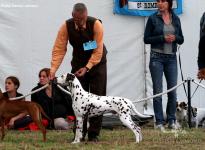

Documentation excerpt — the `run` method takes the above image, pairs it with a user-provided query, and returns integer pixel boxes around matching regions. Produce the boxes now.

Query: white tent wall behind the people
[0,0,205,111]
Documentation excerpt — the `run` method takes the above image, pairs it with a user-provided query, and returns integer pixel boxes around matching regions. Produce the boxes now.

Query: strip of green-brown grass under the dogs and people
[0,127,205,150]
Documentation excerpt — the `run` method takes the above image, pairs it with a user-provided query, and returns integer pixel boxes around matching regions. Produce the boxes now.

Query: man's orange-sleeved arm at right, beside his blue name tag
[86,20,103,69]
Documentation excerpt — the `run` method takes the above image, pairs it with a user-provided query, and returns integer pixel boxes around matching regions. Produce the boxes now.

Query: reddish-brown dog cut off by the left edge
[0,89,50,141]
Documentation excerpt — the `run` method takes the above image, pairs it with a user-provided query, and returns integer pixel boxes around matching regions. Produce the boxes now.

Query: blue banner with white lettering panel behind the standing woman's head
[113,0,182,16]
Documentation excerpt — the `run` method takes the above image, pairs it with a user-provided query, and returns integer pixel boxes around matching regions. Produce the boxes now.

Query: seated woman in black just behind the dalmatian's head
[31,68,74,130]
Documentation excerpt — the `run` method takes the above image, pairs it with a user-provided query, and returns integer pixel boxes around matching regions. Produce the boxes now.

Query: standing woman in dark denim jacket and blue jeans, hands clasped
[144,0,184,131]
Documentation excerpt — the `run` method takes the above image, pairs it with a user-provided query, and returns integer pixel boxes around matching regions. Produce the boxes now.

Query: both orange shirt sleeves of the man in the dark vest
[51,20,103,73]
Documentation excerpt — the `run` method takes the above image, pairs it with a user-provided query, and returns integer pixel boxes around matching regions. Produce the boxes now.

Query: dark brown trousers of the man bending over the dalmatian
[72,62,107,138]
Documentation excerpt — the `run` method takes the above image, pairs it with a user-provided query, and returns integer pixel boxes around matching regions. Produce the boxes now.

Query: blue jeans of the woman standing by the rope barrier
[149,52,178,125]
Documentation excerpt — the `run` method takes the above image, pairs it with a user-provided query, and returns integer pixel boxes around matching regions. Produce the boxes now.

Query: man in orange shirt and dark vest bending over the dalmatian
[50,3,107,141]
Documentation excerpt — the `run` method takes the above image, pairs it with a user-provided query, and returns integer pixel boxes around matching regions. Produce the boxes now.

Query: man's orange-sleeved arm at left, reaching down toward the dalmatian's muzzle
[50,22,69,79]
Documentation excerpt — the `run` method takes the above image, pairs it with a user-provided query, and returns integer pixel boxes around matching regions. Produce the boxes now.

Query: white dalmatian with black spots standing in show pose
[56,73,151,143]
